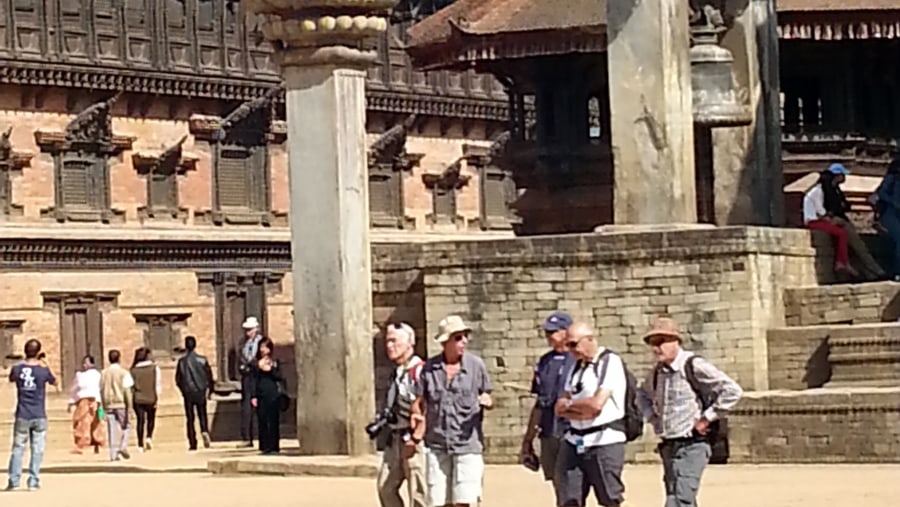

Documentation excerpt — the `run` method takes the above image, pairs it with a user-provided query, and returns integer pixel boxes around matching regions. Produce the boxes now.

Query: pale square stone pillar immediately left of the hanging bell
[607,0,697,224]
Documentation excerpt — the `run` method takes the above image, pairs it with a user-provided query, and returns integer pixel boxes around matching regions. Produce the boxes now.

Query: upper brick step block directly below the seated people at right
[784,282,900,326]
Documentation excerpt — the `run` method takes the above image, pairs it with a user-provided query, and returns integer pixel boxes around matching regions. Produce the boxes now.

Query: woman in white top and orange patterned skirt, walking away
[69,356,105,454]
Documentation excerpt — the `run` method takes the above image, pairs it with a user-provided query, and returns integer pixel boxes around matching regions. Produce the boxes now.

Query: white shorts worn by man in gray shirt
[425,449,484,507]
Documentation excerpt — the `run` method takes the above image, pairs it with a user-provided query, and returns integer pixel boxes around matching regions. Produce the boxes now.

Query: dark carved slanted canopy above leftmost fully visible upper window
[34,92,136,155]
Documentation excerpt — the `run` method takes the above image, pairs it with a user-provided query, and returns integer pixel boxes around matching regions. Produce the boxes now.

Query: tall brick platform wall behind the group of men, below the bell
[375,227,816,461]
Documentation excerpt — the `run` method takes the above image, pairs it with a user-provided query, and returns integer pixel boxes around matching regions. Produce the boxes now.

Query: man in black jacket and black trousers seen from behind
[175,336,213,451]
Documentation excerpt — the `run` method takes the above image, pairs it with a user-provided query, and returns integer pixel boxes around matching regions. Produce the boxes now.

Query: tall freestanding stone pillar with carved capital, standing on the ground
[247,0,394,455]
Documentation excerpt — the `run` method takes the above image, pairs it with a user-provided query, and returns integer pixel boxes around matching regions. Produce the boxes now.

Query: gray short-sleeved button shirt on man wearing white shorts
[418,353,493,454]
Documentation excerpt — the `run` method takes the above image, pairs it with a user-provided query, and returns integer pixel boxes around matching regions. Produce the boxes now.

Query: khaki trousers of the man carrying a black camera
[378,435,429,507]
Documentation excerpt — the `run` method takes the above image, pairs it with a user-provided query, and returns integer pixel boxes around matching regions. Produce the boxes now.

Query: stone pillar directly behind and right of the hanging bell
[712,0,784,225]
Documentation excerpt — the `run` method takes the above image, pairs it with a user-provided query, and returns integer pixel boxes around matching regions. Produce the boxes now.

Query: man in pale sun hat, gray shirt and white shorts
[412,315,494,507]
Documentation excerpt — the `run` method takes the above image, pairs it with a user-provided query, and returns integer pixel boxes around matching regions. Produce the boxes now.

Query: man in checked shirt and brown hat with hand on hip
[638,317,743,507]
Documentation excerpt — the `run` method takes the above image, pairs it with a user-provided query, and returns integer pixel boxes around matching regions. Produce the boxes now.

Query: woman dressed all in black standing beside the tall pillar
[250,338,285,454]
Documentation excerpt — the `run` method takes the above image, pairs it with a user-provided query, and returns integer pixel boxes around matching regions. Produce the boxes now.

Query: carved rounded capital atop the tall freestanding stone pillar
[245,0,397,68]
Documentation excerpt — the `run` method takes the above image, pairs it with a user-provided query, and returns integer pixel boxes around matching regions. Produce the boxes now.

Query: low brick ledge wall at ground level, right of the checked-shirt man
[729,388,900,463]
